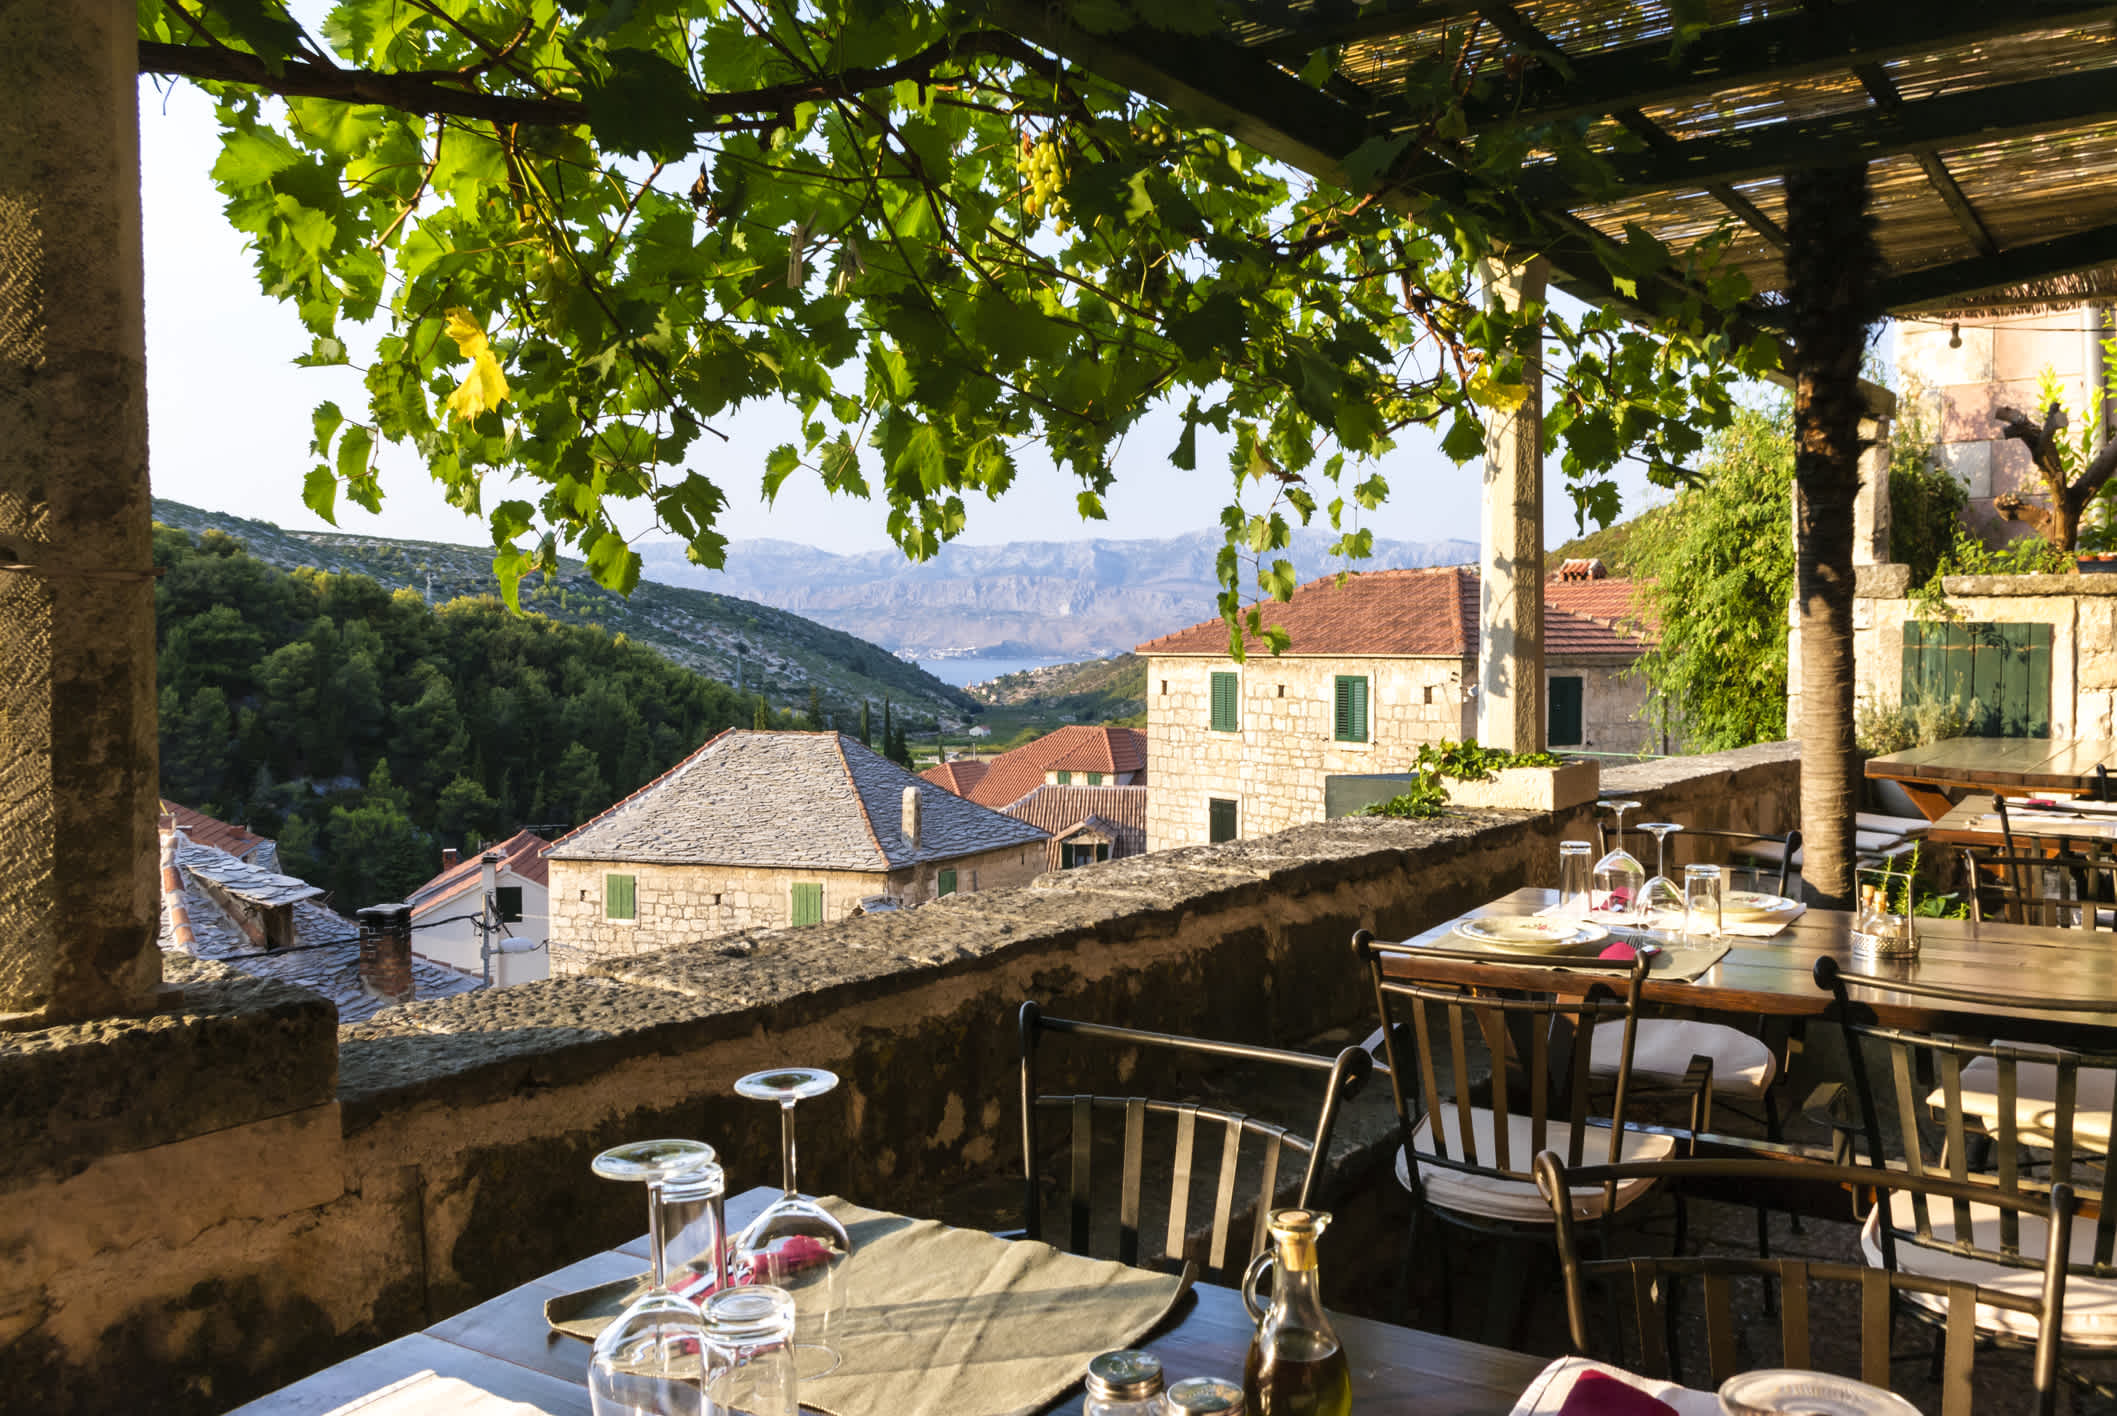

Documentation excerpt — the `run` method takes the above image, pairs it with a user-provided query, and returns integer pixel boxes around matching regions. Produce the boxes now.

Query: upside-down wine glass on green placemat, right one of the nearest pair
[735,1067,853,1378]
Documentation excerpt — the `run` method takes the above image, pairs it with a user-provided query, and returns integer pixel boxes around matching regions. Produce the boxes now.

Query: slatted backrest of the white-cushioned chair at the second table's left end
[1353,929,1649,1209]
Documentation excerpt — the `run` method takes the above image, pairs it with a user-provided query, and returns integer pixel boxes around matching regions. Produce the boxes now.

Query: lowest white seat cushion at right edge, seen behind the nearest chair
[1859,1192,2117,1348]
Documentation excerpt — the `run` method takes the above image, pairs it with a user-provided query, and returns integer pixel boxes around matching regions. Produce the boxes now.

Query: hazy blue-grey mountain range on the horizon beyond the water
[637,529,1478,658]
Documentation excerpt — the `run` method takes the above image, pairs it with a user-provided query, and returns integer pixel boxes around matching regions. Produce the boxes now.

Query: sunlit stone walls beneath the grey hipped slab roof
[550,840,1044,974]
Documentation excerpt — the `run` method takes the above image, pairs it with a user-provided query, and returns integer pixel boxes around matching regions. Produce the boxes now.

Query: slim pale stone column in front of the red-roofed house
[1478,256,1548,751]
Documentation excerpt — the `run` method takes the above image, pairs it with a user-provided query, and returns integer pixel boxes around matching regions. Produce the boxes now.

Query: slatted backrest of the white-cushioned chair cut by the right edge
[1814,957,2117,1276]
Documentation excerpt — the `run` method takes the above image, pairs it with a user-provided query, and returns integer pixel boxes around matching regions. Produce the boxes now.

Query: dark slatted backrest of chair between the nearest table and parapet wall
[1020,1003,1374,1283]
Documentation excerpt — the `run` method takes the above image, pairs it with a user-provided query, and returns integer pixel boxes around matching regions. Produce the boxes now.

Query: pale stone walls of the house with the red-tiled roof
[1147,654,1658,851]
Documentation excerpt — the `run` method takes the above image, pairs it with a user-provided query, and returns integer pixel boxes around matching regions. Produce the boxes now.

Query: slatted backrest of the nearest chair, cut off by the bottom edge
[1537,1154,2077,1416]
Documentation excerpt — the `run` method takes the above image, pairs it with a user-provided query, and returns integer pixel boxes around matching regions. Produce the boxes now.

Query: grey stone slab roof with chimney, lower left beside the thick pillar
[161,834,481,1024]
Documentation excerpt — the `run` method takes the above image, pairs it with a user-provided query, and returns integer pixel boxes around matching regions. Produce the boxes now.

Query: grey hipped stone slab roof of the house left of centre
[550,728,1044,872]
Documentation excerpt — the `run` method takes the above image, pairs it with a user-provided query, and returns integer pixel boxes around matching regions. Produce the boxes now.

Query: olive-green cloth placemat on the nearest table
[544,1198,1192,1416]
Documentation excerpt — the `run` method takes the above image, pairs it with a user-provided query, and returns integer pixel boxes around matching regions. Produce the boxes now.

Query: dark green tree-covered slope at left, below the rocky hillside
[155,525,906,908]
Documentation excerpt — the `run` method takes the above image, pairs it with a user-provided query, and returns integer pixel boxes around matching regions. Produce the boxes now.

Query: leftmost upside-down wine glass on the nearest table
[589,1141,718,1416]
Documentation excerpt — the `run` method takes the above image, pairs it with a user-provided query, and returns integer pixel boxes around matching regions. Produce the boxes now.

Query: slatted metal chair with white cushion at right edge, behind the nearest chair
[1814,957,2117,1357]
